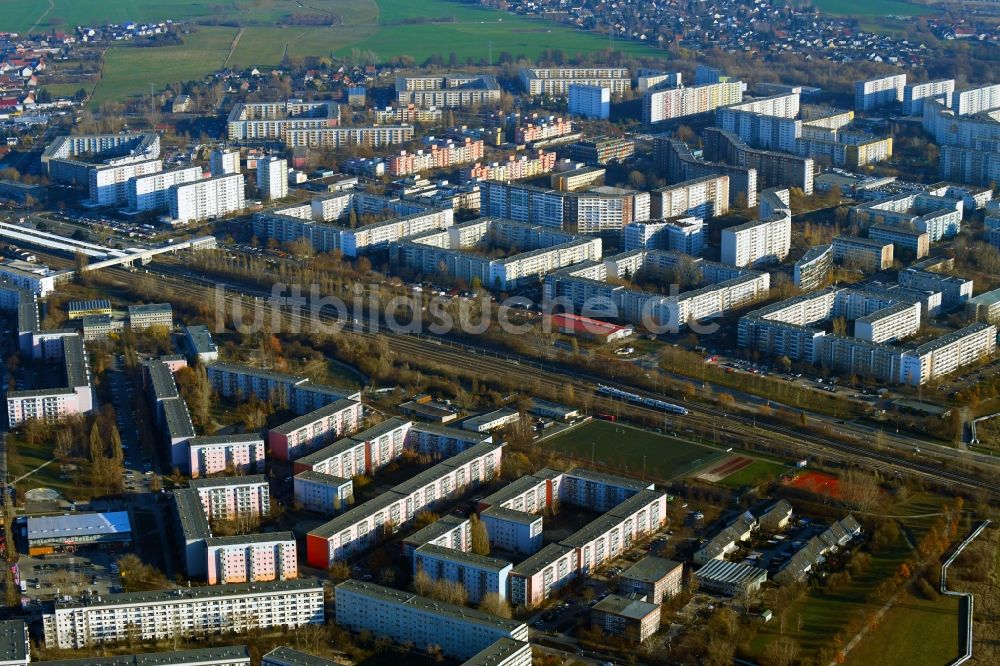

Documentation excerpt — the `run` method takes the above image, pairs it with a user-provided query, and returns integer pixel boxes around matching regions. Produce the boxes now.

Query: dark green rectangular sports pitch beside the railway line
[544,420,723,480]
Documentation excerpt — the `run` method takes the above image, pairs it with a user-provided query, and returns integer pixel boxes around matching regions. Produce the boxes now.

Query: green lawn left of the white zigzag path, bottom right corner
[844,595,959,666]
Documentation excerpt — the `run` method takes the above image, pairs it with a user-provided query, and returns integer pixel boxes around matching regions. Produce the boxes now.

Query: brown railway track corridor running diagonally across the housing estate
[103,266,1000,497]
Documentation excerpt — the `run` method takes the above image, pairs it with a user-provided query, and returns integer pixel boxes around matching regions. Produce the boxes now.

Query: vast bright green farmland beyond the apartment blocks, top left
[37,0,662,104]
